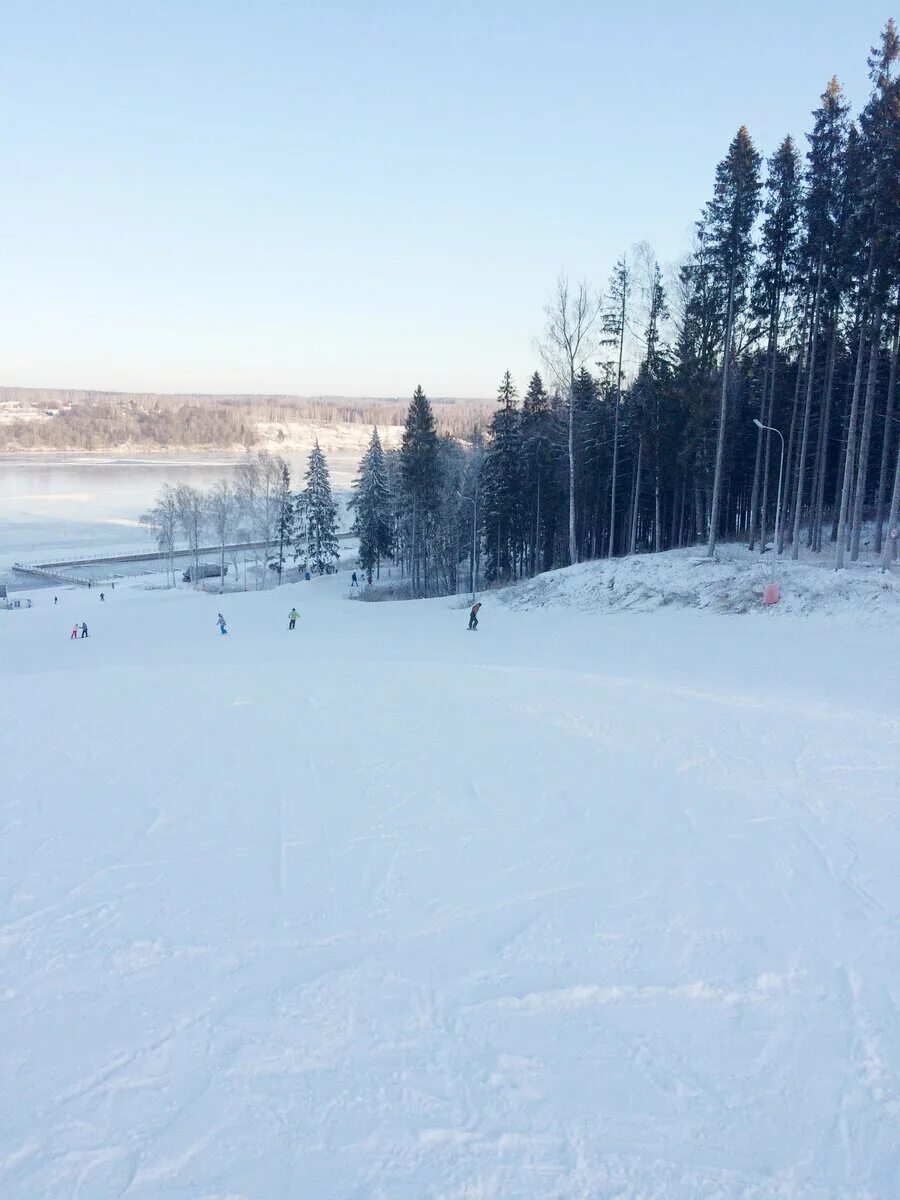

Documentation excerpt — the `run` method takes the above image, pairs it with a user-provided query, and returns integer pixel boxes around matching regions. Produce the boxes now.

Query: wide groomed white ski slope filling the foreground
[0,576,900,1200]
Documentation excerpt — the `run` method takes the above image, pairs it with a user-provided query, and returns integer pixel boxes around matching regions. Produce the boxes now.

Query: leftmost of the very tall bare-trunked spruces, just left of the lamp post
[707,125,760,557]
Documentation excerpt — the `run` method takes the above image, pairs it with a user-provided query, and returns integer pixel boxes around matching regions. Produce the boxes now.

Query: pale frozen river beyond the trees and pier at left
[0,454,347,587]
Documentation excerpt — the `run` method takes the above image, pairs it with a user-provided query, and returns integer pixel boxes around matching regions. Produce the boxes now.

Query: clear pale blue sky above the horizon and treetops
[0,0,892,396]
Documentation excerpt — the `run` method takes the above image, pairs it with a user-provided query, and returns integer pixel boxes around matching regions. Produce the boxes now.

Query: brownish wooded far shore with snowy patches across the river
[0,388,488,450]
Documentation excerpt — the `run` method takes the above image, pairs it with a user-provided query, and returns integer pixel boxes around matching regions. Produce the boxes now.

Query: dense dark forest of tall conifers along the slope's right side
[348,22,900,595]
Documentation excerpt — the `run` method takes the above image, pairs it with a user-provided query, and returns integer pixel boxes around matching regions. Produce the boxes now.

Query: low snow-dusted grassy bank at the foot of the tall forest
[497,545,900,622]
